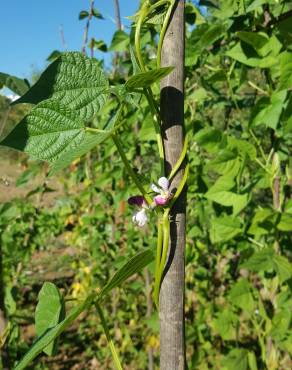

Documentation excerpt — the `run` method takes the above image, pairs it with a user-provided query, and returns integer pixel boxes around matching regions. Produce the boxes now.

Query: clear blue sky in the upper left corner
[0,0,139,80]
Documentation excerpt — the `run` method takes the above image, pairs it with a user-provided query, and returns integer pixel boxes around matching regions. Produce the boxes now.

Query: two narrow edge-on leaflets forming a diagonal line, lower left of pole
[14,249,154,370]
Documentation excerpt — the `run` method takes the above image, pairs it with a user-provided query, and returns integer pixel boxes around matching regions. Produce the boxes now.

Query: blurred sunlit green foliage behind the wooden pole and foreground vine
[0,0,292,370]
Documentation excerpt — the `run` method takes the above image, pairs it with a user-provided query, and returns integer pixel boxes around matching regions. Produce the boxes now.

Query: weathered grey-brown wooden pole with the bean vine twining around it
[159,0,186,370]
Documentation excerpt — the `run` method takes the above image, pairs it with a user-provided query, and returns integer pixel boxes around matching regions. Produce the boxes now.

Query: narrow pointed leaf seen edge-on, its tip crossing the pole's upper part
[125,67,174,91]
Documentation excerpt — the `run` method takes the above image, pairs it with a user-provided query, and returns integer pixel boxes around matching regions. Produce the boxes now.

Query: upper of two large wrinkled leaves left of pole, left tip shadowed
[15,52,108,120]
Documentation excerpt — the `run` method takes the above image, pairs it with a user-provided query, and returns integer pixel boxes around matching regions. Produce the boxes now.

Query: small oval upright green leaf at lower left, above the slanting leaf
[35,283,65,356]
